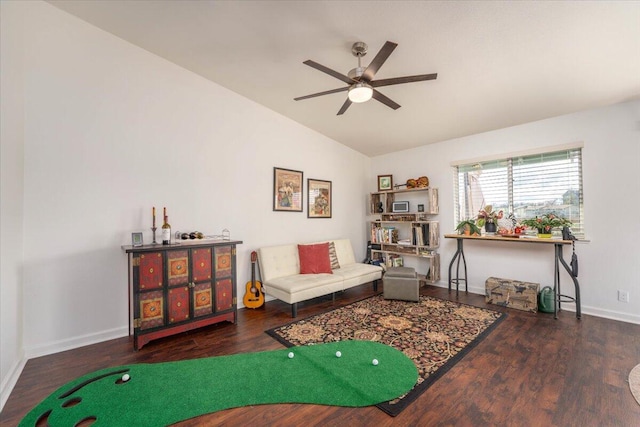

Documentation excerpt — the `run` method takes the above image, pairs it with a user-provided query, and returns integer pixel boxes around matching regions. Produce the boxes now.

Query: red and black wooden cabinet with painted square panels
[123,240,242,350]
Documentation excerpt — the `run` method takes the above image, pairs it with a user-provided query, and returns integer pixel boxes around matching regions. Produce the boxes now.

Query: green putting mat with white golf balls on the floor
[20,341,418,427]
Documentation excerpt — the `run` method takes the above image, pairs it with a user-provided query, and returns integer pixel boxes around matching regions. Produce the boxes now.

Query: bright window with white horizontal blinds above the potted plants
[453,147,584,237]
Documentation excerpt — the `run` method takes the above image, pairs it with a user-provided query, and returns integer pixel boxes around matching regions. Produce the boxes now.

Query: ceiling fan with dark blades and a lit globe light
[293,41,438,115]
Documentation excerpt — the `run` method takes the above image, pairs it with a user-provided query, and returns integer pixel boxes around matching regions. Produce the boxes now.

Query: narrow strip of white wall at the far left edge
[0,2,24,408]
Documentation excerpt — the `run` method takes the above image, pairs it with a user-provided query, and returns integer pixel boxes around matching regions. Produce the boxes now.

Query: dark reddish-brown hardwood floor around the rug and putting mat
[0,285,640,427]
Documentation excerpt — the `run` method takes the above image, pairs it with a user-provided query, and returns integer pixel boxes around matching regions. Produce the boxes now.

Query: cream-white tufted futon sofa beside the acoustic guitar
[257,239,382,317]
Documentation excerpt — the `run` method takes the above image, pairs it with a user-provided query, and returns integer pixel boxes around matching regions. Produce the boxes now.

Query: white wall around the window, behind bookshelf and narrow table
[370,101,640,323]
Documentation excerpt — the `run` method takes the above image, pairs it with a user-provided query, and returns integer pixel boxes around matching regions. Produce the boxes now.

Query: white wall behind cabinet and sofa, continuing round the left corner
[1,2,370,406]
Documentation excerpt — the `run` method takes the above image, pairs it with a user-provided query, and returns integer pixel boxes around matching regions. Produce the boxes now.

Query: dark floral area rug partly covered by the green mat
[266,295,506,416]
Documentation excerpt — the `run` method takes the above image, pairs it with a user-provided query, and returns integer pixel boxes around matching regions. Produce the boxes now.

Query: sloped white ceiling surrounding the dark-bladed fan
[50,0,640,156]
